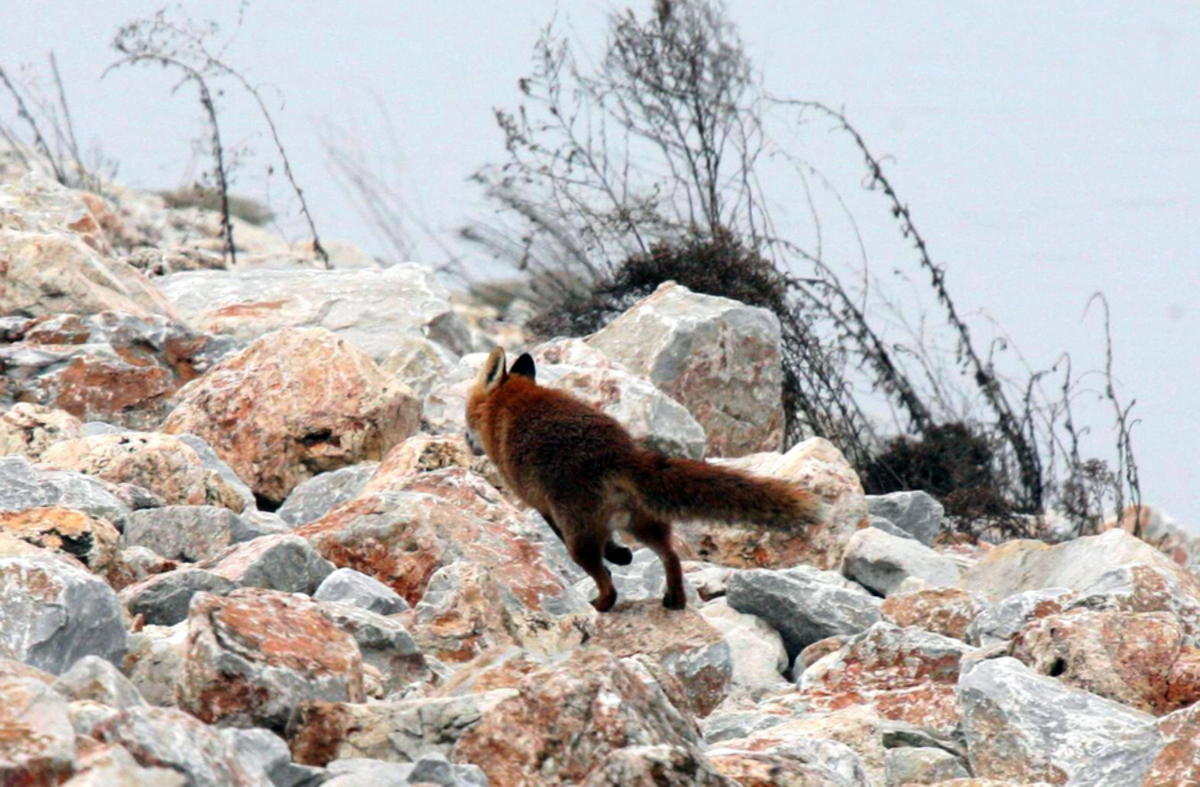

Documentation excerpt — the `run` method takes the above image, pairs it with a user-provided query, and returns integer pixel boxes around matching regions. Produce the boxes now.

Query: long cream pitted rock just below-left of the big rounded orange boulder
[42,432,245,511]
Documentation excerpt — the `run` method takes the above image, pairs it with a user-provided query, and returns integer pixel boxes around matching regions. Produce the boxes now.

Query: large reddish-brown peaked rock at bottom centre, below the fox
[451,648,696,787]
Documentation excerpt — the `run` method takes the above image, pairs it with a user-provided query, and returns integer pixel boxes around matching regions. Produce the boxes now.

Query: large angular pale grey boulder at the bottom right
[959,659,1163,787]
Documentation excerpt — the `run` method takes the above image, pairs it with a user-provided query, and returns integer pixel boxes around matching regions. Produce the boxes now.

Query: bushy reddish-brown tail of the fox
[630,451,824,530]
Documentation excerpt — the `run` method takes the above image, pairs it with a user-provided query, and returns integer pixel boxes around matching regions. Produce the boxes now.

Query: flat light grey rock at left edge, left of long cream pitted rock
[0,456,130,522]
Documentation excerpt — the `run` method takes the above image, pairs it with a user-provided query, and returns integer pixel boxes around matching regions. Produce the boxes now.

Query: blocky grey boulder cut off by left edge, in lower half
[0,557,126,674]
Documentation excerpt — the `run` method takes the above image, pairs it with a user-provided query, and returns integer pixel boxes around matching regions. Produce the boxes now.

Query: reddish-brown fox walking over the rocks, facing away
[466,347,824,612]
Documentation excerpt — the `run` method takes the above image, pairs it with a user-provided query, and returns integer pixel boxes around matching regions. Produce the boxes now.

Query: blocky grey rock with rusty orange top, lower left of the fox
[179,588,364,731]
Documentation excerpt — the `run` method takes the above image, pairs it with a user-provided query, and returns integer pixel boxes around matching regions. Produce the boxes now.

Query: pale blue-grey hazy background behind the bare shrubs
[0,0,1200,530]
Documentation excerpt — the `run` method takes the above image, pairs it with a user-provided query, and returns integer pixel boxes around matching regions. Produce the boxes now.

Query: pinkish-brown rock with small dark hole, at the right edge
[1010,609,1196,715]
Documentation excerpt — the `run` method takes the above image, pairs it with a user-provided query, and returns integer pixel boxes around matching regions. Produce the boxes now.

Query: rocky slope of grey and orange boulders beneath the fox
[0,150,1200,787]
